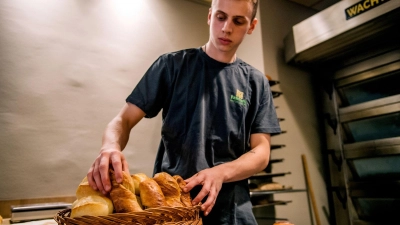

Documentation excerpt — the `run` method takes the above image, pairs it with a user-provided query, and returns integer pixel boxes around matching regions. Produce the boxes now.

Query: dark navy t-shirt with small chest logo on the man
[126,48,281,225]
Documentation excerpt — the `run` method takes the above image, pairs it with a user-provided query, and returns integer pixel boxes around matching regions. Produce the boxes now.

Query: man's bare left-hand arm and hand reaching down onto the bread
[87,103,145,194]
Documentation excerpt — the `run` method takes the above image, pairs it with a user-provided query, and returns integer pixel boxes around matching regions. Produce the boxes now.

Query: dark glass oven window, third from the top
[350,155,400,180]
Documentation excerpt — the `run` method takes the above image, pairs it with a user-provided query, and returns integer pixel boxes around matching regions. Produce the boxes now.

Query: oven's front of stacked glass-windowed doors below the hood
[334,49,400,224]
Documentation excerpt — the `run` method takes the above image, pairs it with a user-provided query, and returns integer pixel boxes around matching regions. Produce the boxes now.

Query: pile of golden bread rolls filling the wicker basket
[70,170,192,218]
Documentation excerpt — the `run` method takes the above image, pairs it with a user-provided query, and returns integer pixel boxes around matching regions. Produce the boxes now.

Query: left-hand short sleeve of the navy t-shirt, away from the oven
[126,55,171,118]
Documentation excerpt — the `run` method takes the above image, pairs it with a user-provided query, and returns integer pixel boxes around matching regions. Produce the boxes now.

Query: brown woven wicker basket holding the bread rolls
[54,206,203,225]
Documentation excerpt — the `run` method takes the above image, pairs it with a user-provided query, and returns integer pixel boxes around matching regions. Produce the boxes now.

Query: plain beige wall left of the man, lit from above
[0,0,208,200]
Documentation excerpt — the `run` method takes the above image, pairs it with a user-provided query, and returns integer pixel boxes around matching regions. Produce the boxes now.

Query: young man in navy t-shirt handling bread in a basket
[88,0,280,225]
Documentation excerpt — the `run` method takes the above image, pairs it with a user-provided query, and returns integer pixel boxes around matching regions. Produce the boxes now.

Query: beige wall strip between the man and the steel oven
[260,0,329,225]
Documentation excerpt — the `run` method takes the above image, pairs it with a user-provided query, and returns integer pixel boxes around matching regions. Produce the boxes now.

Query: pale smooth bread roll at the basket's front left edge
[71,195,113,218]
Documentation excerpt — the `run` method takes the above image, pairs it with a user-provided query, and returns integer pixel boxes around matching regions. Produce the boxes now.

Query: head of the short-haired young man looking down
[208,0,257,53]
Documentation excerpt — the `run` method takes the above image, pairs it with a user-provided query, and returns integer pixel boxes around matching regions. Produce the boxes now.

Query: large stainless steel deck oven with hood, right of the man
[285,0,400,225]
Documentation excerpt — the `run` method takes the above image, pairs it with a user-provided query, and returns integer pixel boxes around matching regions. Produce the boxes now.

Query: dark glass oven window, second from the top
[343,111,400,142]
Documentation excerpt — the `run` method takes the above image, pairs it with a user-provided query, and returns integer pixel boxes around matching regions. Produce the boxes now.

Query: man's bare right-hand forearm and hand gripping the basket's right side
[185,133,271,215]
